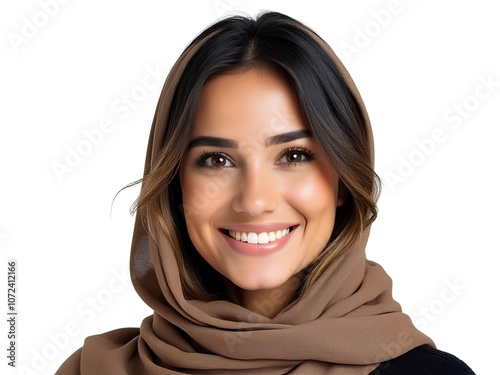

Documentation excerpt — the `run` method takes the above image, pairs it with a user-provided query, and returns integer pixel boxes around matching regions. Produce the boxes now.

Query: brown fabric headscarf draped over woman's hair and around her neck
[56,11,434,375]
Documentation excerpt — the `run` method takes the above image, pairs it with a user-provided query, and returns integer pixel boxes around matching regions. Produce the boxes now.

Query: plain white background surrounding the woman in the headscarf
[0,0,500,374]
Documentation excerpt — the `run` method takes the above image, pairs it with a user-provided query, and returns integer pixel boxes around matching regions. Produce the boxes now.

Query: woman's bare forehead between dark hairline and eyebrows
[193,69,307,139]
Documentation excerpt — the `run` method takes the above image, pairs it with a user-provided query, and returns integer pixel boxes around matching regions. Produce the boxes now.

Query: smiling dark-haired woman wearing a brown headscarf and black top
[57,13,473,374]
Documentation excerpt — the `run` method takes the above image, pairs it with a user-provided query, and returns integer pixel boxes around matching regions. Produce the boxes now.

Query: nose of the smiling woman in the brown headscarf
[233,166,279,217]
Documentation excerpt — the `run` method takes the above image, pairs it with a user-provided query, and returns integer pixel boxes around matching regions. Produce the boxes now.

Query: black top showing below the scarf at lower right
[370,345,474,375]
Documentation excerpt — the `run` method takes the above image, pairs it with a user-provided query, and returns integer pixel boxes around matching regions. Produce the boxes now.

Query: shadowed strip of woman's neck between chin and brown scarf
[226,276,300,319]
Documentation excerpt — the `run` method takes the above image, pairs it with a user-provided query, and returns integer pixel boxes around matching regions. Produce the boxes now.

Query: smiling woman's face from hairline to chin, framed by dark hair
[180,69,339,290]
